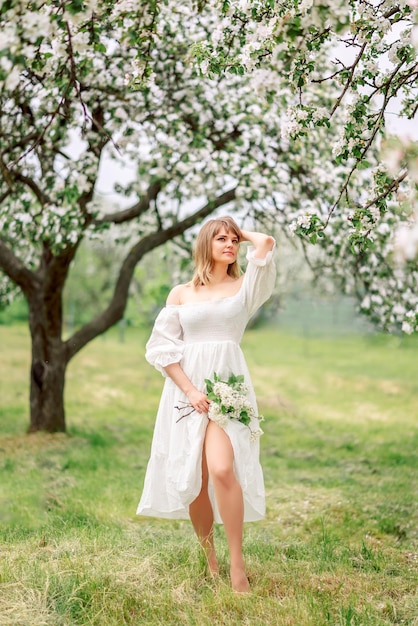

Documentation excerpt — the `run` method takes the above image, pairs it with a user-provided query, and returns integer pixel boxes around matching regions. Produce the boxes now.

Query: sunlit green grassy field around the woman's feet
[0,326,418,626]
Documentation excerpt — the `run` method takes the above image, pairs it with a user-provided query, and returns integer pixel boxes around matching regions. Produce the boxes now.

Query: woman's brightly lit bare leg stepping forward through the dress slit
[205,422,250,592]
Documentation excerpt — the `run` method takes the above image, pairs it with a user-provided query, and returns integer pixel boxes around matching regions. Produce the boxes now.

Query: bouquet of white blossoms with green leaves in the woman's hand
[176,372,264,440]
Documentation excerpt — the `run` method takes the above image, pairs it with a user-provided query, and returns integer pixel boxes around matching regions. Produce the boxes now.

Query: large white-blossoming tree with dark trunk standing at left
[0,0,418,432]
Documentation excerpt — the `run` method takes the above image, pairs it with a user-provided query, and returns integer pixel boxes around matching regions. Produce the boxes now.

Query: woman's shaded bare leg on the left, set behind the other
[189,447,219,574]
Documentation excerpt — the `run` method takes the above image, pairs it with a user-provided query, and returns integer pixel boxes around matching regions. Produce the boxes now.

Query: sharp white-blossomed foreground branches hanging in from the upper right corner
[194,0,418,333]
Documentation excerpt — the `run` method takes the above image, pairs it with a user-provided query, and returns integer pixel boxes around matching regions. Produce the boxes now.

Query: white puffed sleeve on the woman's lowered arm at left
[145,305,184,376]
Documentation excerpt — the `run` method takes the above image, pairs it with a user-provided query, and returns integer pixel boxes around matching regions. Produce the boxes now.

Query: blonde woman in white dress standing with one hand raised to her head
[137,217,275,592]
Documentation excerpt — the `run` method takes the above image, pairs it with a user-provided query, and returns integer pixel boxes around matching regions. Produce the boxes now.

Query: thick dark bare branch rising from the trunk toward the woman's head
[65,188,235,362]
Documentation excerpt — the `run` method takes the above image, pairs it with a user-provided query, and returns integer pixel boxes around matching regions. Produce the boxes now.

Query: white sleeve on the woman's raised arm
[243,239,276,317]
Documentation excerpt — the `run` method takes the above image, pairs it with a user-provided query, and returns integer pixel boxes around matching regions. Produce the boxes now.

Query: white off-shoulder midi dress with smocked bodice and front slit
[137,248,275,522]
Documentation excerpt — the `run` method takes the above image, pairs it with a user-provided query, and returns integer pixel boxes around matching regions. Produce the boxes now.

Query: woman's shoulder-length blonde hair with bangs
[192,216,242,287]
